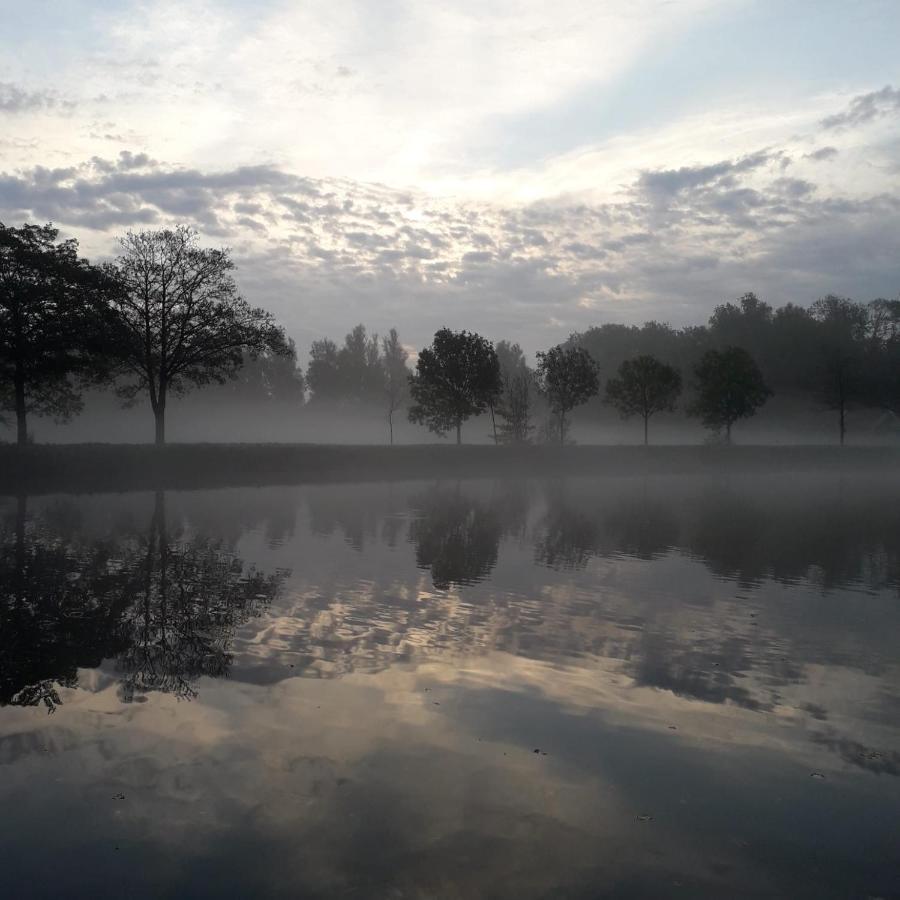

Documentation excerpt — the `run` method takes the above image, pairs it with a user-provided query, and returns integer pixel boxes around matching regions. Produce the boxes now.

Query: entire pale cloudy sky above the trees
[0,0,900,351]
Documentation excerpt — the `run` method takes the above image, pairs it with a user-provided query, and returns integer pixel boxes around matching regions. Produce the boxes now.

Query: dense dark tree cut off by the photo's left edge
[0,223,114,445]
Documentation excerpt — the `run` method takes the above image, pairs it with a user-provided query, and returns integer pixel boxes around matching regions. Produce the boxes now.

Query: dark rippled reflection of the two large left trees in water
[0,492,284,711]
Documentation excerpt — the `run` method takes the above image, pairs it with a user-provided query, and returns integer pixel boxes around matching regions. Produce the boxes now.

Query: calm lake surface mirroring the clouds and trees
[0,475,900,898]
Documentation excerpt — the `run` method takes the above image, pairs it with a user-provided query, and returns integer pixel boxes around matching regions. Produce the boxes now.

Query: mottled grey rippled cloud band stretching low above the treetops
[0,127,900,358]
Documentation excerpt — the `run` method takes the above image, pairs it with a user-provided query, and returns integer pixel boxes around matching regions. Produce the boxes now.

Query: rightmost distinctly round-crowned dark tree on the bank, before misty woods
[688,347,772,443]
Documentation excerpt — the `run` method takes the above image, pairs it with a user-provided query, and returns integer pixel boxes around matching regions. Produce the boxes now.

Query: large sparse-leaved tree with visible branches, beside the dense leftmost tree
[114,225,289,444]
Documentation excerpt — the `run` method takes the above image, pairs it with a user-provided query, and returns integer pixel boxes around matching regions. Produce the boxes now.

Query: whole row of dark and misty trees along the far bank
[0,223,900,444]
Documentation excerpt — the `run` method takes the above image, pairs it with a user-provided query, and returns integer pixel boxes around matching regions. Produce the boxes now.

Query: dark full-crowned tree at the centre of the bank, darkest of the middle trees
[409,328,500,444]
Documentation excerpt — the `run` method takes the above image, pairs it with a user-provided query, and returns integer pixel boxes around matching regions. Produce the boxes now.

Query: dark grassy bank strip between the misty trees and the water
[0,444,900,494]
